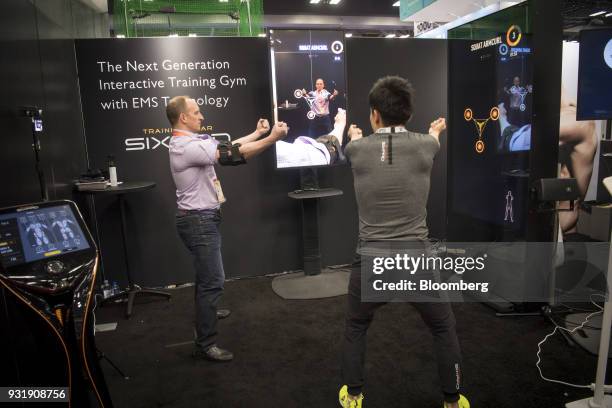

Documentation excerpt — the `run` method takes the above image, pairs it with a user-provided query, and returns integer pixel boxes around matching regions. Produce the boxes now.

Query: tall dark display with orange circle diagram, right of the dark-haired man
[449,2,536,240]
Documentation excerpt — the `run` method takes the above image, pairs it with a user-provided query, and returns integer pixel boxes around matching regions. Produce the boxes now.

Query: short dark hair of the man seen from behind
[369,76,414,125]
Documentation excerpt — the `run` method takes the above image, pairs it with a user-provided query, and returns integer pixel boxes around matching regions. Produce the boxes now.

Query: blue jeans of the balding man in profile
[176,209,225,350]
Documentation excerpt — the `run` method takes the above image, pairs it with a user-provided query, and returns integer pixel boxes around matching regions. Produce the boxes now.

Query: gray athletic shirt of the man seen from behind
[345,132,440,242]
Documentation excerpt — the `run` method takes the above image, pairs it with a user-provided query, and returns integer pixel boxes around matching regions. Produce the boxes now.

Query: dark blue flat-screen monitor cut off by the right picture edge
[576,28,612,120]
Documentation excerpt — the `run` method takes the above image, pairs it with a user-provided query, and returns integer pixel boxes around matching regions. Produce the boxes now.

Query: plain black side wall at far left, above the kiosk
[0,0,87,207]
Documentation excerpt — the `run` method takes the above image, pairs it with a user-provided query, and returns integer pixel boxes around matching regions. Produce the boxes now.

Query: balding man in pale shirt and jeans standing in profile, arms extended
[166,96,288,361]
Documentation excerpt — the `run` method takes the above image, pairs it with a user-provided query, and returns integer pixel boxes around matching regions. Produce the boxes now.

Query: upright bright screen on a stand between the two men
[270,30,346,168]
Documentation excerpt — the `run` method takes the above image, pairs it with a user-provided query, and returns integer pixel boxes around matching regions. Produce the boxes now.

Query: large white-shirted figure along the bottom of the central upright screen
[276,108,346,168]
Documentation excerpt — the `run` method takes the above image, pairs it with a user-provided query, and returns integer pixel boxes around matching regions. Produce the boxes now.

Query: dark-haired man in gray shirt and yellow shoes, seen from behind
[339,76,469,408]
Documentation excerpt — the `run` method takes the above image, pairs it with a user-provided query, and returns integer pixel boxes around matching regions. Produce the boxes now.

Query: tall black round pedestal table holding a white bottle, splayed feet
[82,181,172,317]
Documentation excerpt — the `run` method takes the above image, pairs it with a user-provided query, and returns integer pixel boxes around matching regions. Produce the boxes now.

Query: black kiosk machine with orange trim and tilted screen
[0,201,112,408]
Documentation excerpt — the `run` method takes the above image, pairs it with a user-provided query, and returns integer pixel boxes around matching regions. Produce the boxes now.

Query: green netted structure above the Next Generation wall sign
[113,0,264,37]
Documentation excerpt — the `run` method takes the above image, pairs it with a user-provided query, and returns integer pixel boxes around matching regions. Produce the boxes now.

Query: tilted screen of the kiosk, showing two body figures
[0,204,90,268]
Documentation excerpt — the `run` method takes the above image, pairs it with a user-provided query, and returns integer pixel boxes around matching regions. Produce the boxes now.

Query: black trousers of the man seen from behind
[342,261,462,402]
